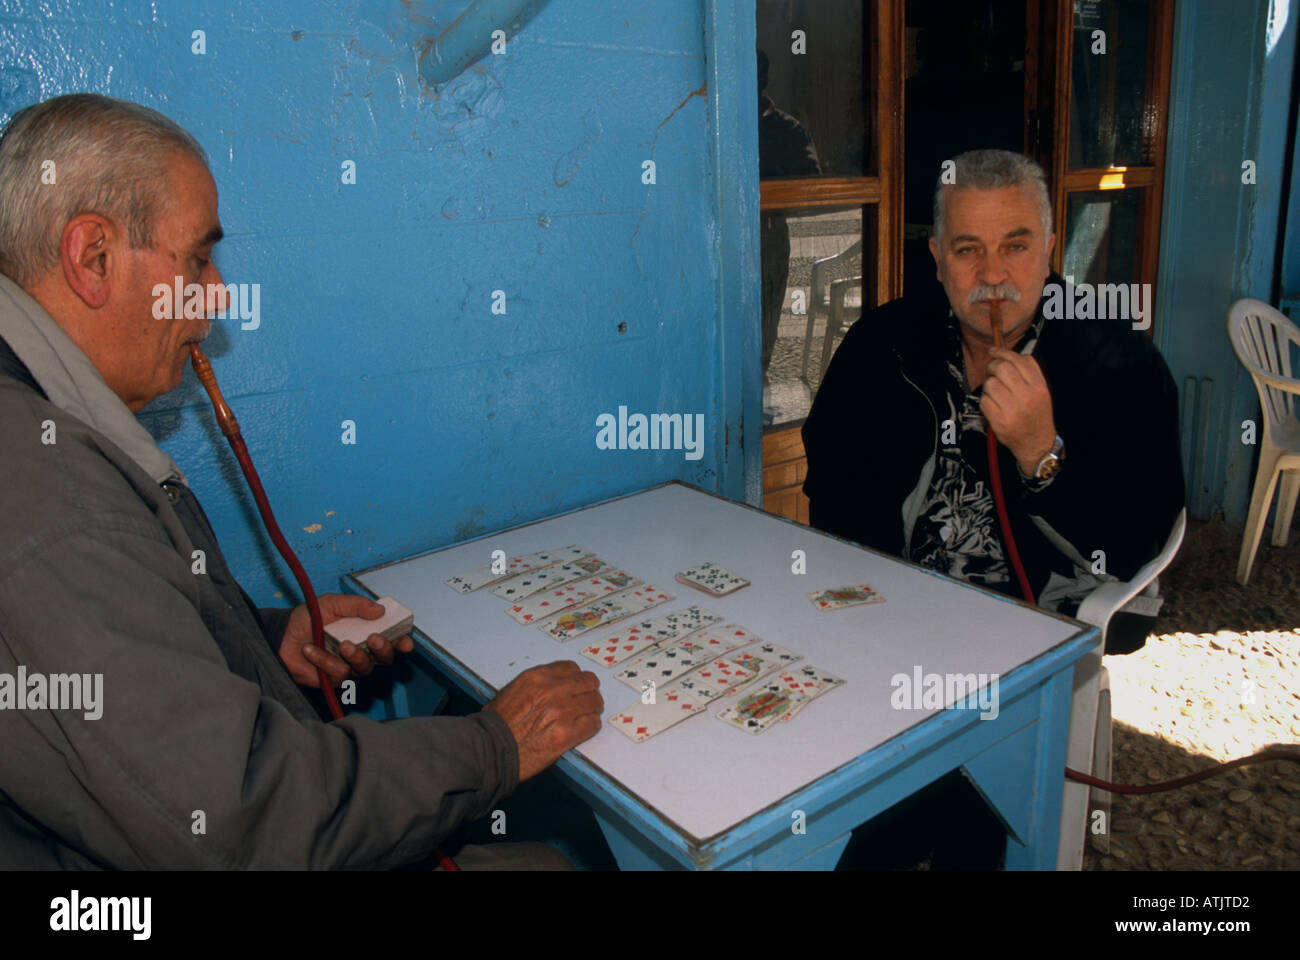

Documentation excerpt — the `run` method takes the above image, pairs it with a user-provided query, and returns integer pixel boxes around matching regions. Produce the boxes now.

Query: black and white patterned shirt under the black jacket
[910,310,1050,592]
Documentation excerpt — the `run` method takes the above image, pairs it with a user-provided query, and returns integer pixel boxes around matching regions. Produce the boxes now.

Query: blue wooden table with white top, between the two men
[345,483,1097,870]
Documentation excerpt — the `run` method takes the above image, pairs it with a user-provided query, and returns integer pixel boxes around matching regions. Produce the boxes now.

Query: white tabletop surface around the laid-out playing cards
[356,484,1082,839]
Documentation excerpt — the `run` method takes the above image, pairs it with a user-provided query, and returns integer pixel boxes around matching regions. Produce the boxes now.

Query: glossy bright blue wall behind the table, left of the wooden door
[0,0,759,604]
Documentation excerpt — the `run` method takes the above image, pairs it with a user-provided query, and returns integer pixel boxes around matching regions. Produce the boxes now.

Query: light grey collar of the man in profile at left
[0,273,186,484]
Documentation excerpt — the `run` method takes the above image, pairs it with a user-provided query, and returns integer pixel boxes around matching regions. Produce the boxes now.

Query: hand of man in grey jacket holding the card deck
[280,593,415,687]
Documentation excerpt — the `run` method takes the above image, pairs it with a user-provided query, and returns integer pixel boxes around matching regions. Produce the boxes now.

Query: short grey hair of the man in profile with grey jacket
[0,94,208,286]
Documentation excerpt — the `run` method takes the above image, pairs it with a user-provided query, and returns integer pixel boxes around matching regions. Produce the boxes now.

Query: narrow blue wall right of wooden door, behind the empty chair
[1154,0,1300,524]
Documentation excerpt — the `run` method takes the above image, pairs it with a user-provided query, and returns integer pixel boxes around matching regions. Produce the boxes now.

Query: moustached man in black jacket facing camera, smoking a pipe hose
[803,150,1184,865]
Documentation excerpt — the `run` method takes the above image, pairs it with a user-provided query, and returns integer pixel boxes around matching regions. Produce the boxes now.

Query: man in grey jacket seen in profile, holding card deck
[0,94,603,869]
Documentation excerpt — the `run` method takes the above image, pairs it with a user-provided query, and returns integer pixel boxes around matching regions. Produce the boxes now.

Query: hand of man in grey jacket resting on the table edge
[484,660,605,783]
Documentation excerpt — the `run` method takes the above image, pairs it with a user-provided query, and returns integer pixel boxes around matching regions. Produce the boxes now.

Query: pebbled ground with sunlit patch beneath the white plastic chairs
[1084,522,1300,870]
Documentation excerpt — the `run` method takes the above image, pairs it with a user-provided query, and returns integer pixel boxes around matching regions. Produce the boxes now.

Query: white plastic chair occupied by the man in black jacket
[1057,509,1187,870]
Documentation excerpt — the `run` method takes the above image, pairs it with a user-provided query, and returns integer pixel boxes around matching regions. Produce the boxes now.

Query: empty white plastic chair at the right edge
[1227,299,1300,587]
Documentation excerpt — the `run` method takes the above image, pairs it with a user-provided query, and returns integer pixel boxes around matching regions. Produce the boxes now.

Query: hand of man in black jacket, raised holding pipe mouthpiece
[979,347,1057,476]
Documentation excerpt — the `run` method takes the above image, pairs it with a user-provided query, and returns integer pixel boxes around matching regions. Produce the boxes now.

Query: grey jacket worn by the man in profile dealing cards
[0,276,519,869]
